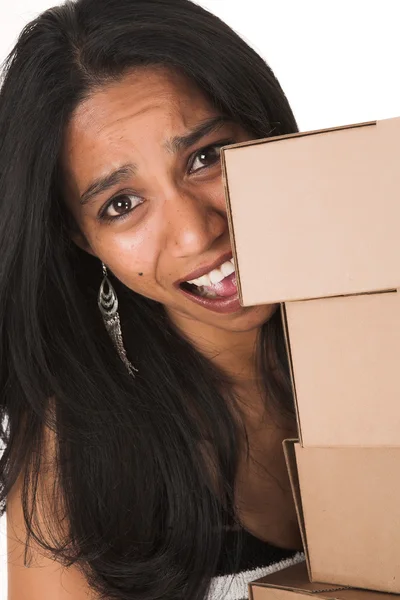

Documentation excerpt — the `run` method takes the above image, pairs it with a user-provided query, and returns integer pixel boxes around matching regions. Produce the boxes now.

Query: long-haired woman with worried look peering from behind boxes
[0,0,303,600]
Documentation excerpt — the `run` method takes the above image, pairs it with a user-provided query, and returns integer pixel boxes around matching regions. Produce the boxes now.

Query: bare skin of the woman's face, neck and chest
[63,67,301,548]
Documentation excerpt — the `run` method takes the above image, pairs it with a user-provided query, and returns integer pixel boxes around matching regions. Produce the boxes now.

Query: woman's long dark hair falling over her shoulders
[0,0,297,600]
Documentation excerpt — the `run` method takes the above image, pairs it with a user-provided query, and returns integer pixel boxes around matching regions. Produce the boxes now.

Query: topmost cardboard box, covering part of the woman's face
[221,117,400,306]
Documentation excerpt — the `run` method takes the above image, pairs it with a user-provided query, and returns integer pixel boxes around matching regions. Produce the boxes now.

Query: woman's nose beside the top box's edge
[166,190,228,258]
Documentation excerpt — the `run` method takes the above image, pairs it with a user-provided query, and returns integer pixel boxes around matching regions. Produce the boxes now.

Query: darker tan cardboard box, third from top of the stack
[284,440,400,594]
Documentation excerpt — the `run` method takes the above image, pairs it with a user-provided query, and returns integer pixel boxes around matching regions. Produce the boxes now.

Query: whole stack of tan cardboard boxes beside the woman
[222,118,400,600]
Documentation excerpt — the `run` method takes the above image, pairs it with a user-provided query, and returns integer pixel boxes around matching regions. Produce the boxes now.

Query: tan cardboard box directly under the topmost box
[282,288,400,448]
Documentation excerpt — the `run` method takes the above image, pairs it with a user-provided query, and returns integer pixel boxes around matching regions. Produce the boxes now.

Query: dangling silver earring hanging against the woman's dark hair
[97,262,138,377]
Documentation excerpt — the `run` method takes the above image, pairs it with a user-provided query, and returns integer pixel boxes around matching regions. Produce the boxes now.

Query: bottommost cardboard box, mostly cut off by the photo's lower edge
[249,563,400,600]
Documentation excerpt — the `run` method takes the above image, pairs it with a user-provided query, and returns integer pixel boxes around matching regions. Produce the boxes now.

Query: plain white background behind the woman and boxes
[0,0,400,600]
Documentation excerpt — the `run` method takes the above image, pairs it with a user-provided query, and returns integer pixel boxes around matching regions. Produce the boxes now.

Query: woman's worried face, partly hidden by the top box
[63,67,274,338]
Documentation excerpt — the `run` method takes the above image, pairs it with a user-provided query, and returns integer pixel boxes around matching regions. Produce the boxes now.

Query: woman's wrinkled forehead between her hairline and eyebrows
[64,67,215,167]
